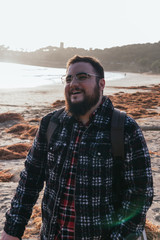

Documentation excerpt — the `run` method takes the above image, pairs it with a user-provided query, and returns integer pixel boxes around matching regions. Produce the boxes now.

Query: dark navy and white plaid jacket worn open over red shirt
[4,98,153,240]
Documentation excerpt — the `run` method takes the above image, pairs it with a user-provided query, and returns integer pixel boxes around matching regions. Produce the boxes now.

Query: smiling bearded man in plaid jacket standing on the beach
[1,56,153,240]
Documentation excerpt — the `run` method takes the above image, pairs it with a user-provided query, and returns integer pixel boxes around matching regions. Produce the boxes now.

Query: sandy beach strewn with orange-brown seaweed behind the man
[0,73,160,239]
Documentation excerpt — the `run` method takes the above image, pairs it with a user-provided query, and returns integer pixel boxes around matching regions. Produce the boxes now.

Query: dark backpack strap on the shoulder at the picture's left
[46,108,65,144]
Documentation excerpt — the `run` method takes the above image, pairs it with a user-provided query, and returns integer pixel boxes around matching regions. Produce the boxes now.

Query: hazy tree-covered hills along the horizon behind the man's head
[0,41,160,74]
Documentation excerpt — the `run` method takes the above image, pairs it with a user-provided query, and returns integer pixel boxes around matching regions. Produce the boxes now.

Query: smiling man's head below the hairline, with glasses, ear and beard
[62,62,105,123]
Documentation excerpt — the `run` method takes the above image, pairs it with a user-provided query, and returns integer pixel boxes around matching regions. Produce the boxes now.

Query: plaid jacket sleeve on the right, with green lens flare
[111,117,153,240]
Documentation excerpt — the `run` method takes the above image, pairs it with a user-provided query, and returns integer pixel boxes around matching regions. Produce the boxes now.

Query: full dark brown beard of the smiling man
[65,84,100,117]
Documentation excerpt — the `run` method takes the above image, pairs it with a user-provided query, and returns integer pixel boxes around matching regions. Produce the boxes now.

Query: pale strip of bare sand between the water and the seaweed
[0,73,160,108]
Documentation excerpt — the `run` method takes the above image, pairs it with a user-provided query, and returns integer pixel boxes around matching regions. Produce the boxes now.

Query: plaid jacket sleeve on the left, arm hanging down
[4,113,52,238]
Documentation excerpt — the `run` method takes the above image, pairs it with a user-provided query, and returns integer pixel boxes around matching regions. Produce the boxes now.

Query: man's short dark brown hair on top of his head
[66,55,104,79]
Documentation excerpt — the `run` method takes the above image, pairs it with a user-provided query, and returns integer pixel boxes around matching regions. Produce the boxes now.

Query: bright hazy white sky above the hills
[0,0,160,50]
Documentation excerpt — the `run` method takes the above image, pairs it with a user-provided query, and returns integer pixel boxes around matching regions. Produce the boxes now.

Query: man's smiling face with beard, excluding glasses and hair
[65,62,103,116]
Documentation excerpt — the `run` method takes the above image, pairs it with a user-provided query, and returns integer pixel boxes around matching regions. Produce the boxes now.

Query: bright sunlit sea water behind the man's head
[0,62,125,89]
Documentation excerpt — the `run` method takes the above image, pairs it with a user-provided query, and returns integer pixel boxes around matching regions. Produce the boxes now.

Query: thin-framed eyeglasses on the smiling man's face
[61,72,99,84]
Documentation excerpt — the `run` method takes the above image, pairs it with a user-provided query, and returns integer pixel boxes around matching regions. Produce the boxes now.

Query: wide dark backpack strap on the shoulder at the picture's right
[111,108,126,159]
